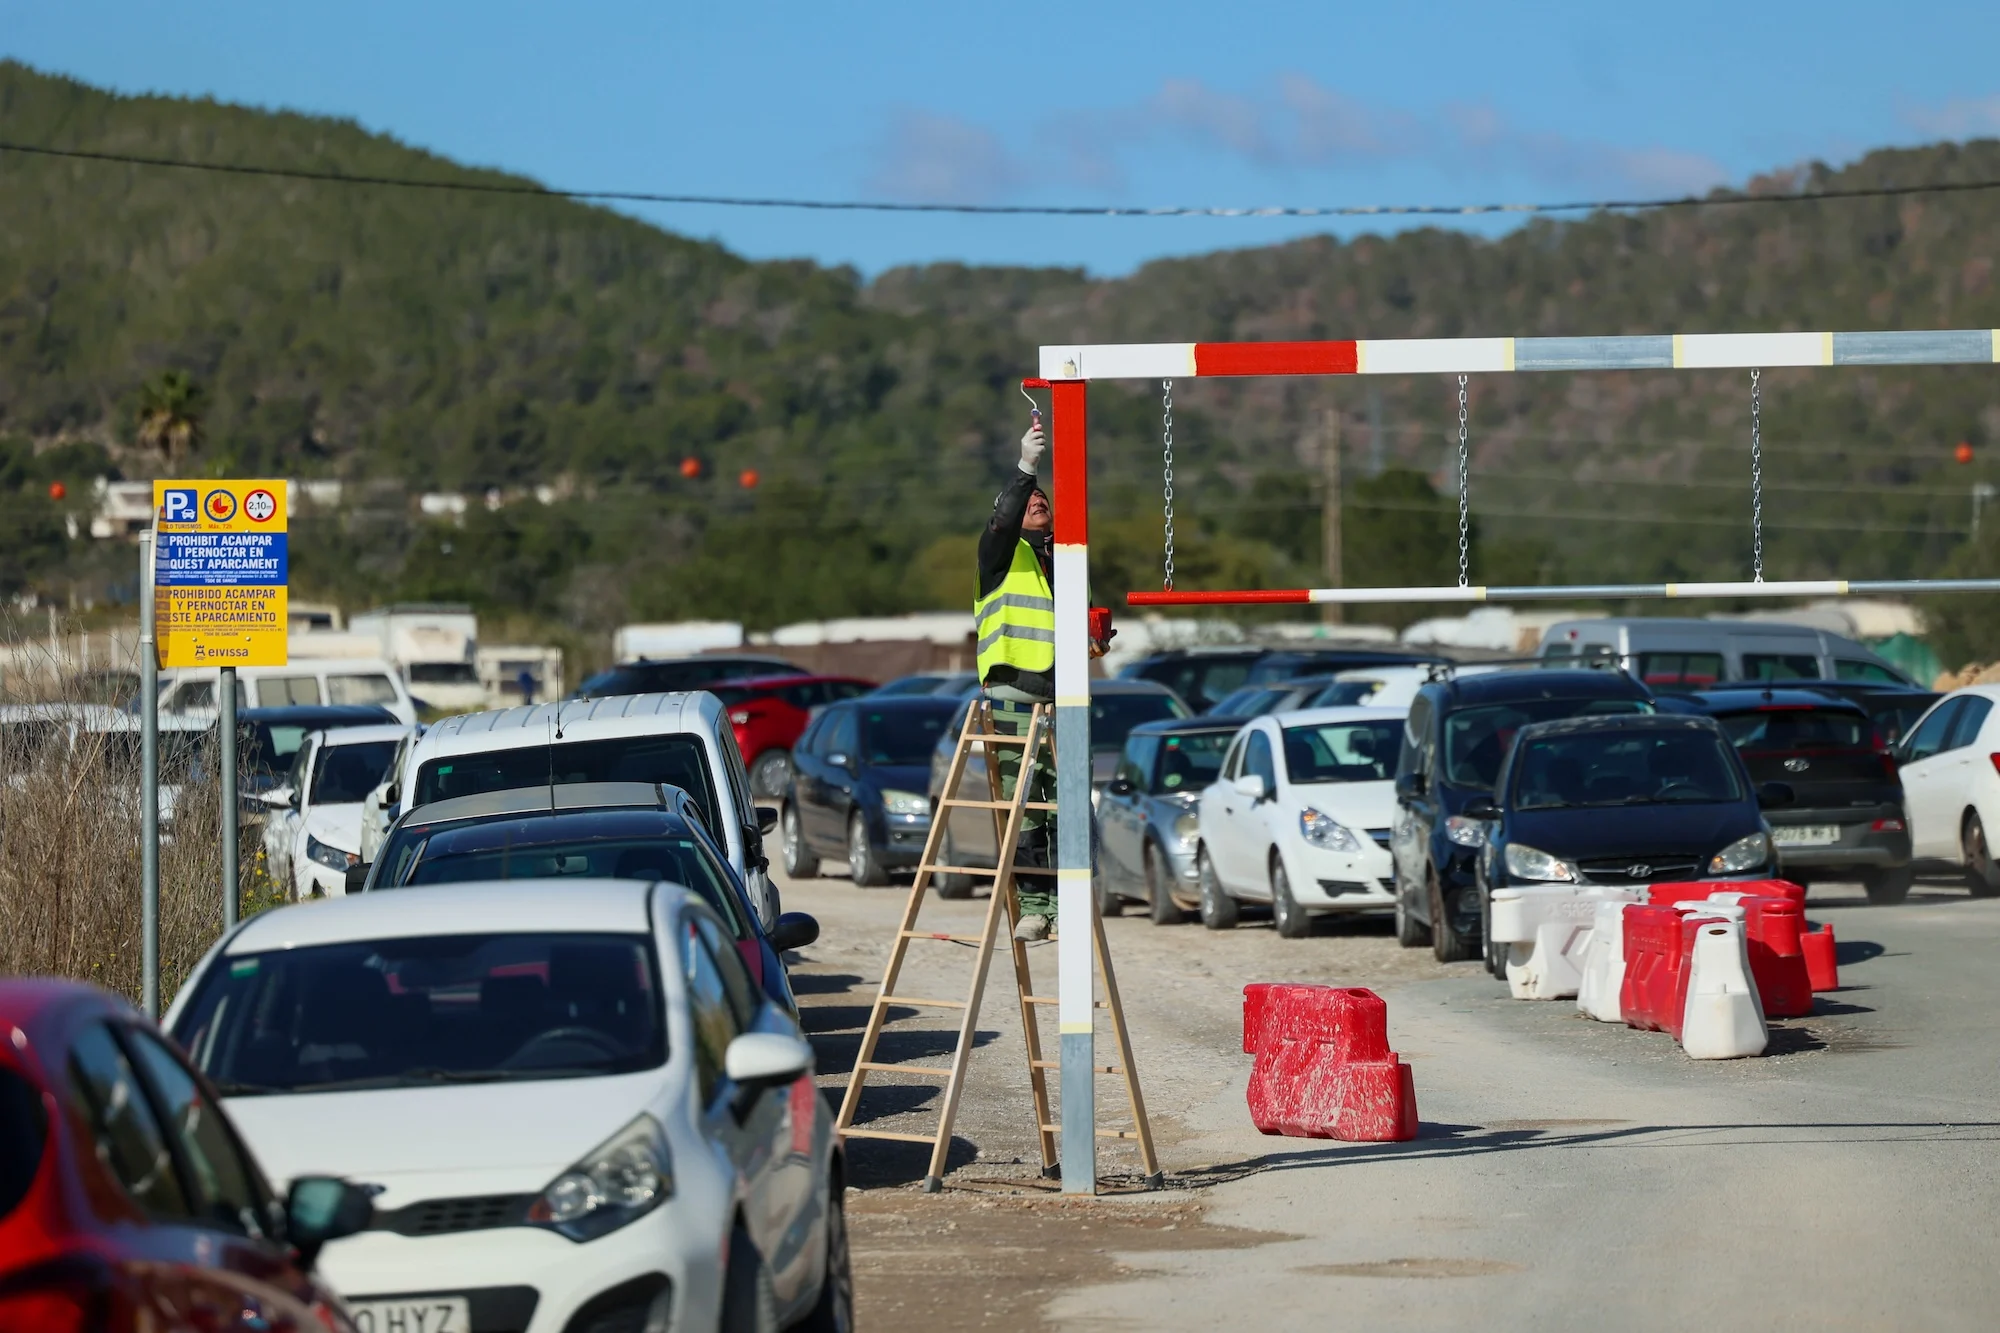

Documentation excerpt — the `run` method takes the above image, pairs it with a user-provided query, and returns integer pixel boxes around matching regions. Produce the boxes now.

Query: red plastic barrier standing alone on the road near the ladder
[1244,983,1416,1143]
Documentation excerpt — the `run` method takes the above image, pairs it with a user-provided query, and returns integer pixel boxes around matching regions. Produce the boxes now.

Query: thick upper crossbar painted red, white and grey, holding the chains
[1042,328,2000,380]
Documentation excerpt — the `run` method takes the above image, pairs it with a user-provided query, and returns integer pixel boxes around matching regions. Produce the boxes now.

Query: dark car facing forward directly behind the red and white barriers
[1464,713,1792,973]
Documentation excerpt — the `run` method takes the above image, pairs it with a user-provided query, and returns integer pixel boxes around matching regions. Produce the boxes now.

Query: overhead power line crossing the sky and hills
[0,140,2000,218]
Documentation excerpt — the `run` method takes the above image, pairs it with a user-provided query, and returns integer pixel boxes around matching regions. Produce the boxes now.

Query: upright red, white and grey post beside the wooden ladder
[1048,380,1098,1195]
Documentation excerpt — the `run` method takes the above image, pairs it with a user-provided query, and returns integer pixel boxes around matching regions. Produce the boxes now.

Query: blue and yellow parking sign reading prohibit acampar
[152,480,290,667]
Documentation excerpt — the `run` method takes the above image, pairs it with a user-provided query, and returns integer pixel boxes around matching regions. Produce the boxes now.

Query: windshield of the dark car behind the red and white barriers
[1514,727,1744,811]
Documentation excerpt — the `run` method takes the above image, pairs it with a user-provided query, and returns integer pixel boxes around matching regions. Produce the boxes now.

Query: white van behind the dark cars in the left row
[388,691,778,931]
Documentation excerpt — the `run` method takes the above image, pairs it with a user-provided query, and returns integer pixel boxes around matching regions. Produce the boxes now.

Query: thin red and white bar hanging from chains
[1126,578,2000,606]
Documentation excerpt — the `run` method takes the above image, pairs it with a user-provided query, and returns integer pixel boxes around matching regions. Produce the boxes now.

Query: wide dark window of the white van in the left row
[408,733,724,831]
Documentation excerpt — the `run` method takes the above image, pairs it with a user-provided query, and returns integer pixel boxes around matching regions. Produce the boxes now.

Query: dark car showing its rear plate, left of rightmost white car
[1686,687,1910,903]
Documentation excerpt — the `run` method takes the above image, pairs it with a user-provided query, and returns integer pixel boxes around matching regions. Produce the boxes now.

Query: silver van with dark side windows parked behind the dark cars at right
[1538,616,1916,691]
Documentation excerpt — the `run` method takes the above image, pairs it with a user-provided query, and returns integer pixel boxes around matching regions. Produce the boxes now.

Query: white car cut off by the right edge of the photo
[1898,685,2000,899]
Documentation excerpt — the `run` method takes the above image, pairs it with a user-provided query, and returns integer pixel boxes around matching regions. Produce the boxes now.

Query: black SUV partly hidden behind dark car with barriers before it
[1390,671,1654,963]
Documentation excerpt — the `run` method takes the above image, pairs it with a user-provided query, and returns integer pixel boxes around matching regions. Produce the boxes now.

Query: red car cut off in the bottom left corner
[0,979,374,1333]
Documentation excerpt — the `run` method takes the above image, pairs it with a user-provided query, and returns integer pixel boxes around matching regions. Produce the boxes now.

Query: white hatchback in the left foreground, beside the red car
[166,881,852,1333]
